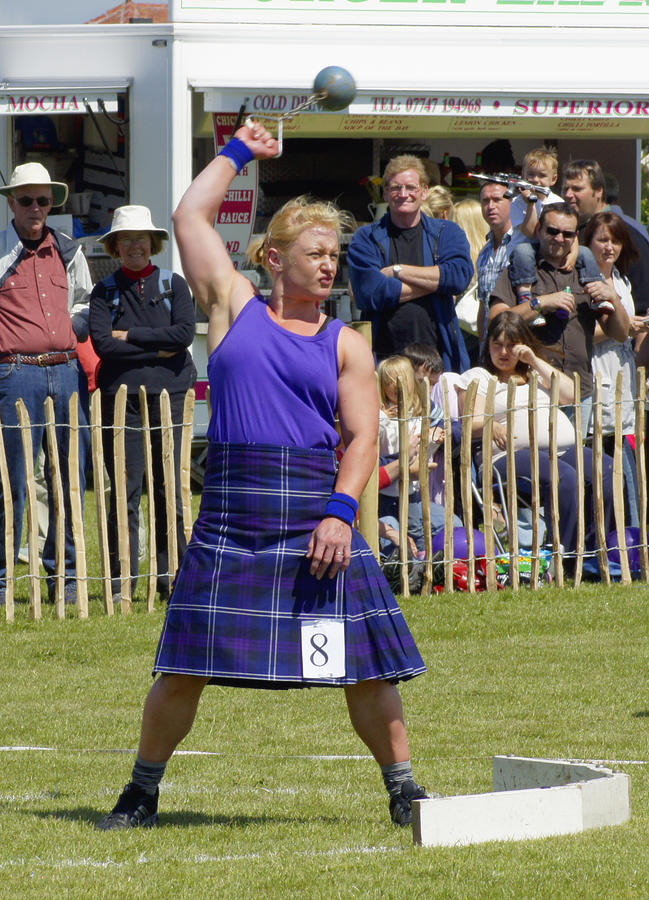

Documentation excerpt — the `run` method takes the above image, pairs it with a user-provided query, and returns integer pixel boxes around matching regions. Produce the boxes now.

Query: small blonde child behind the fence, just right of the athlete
[378,356,444,555]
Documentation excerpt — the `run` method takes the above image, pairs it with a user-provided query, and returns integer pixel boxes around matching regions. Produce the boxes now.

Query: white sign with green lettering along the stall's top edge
[169,0,649,28]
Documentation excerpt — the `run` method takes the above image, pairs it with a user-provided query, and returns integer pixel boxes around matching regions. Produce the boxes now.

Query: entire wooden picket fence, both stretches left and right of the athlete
[0,369,649,621]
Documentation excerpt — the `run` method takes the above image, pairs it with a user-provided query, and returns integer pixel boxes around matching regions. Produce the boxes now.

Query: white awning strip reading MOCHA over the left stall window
[0,79,131,116]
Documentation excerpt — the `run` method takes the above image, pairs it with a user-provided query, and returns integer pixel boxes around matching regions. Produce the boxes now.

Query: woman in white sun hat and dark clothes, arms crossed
[90,206,196,599]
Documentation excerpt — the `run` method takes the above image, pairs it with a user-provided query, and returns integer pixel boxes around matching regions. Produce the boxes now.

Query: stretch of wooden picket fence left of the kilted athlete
[0,385,195,622]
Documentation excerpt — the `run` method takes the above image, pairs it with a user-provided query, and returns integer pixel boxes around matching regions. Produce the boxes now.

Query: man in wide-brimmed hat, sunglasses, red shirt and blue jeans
[0,163,92,603]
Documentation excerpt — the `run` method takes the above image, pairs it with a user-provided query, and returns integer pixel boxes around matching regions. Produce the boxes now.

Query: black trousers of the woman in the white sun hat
[102,392,187,592]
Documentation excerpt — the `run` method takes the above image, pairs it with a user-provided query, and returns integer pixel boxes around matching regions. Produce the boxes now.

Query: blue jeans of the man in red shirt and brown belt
[0,359,90,584]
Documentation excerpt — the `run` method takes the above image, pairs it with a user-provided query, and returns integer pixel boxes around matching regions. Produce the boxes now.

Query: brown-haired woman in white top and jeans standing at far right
[583,211,647,528]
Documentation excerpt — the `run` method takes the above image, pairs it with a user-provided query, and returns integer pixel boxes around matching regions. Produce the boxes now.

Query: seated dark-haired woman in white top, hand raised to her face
[458,311,613,555]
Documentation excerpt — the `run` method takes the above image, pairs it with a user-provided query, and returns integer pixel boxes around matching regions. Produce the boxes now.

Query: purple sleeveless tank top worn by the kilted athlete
[207,296,344,450]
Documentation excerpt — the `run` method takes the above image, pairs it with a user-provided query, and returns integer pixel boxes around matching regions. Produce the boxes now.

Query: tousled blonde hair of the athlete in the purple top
[246,194,355,272]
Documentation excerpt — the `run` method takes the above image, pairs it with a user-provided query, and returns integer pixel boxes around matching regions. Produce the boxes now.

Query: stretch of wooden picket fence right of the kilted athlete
[360,368,649,596]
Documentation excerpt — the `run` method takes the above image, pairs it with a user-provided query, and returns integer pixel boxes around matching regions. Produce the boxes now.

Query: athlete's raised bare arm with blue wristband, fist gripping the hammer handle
[172,122,279,352]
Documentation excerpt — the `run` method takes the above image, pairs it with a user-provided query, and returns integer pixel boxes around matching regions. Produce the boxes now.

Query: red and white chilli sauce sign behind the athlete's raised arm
[212,113,259,269]
